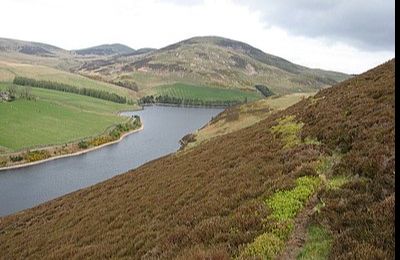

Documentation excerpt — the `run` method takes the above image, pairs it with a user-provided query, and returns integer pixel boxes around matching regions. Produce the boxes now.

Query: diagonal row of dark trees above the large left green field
[13,76,129,104]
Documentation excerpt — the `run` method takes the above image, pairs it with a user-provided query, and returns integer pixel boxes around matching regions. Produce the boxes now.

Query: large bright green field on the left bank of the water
[0,83,132,152]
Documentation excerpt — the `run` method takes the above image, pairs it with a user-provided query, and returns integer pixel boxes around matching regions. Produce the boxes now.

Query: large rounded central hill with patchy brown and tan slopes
[77,37,349,94]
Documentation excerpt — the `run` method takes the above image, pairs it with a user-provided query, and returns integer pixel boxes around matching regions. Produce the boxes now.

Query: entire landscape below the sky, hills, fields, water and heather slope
[0,32,395,259]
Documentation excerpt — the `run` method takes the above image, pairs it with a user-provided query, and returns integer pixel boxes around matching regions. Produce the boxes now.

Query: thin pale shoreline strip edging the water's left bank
[0,123,144,172]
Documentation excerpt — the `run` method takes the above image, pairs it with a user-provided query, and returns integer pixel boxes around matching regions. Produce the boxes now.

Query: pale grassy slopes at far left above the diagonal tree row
[0,38,141,99]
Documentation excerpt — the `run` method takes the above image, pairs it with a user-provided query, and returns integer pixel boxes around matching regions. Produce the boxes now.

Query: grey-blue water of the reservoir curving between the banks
[0,107,222,216]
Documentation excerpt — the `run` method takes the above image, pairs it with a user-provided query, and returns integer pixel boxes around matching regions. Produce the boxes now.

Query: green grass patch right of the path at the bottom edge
[297,225,332,260]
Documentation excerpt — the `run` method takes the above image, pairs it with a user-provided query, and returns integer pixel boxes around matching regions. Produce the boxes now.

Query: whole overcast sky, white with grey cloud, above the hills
[0,0,395,73]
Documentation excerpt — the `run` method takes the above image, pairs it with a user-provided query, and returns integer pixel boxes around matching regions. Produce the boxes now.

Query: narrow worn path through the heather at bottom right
[276,191,318,260]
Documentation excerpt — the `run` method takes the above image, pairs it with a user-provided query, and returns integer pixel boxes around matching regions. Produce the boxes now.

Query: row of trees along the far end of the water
[139,95,247,107]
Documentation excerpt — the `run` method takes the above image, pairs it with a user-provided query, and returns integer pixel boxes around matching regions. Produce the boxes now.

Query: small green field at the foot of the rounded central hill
[156,83,261,101]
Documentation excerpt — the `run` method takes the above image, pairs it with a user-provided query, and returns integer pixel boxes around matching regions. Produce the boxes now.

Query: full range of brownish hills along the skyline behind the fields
[0,37,350,99]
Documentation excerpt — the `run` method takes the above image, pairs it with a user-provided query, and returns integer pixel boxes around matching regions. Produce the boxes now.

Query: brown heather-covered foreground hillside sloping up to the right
[0,59,395,259]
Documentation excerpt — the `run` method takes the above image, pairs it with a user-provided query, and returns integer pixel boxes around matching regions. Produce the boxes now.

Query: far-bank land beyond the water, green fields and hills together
[0,37,349,167]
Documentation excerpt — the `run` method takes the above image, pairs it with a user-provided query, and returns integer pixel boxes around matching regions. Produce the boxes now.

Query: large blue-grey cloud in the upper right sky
[239,0,395,51]
